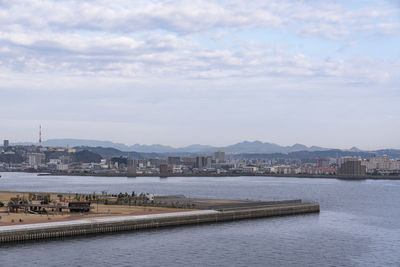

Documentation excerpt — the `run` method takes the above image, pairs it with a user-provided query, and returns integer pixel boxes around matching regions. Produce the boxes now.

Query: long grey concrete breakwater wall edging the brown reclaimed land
[0,203,320,243]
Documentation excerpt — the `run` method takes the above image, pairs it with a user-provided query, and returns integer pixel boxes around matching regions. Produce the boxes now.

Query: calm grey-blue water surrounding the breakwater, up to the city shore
[0,173,400,267]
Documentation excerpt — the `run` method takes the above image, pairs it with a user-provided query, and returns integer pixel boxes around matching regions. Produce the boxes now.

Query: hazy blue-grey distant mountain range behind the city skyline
[11,139,360,154]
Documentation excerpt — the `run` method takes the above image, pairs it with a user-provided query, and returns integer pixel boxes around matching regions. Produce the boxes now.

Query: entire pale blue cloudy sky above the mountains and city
[0,0,400,149]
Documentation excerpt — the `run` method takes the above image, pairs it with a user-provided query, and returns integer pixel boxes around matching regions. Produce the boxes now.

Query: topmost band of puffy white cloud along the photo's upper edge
[0,0,398,37]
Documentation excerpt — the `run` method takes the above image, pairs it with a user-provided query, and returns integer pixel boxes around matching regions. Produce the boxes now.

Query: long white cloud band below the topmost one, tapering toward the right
[0,27,398,82]
